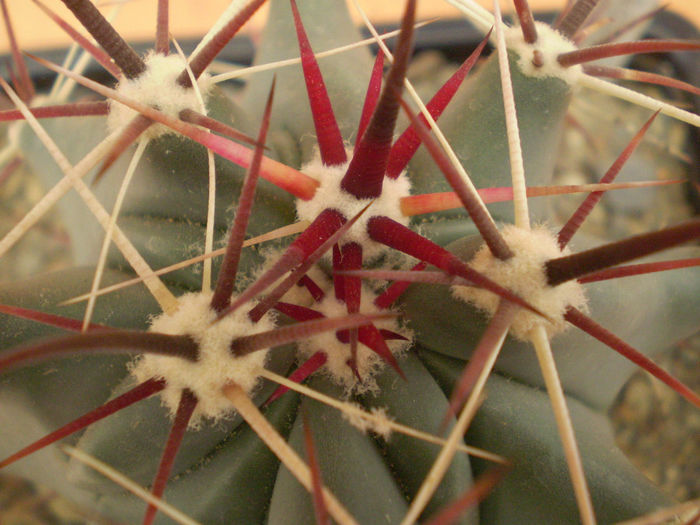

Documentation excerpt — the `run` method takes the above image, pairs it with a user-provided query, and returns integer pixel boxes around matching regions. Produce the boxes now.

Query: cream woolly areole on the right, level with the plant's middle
[452,226,586,341]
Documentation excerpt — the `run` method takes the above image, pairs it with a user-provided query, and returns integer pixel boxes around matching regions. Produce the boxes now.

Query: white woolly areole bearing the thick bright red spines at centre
[297,151,411,261]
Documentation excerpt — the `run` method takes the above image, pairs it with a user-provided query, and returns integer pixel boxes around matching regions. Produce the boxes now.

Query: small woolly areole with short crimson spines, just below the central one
[297,285,411,394]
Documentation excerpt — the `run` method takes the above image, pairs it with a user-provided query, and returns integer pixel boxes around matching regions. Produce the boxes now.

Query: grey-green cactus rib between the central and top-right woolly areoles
[411,49,571,237]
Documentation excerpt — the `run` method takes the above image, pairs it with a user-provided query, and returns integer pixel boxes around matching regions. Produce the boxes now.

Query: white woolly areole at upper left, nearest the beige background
[107,52,210,139]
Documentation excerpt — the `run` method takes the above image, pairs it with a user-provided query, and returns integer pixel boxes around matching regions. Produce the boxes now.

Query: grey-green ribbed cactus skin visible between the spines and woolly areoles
[0,0,700,523]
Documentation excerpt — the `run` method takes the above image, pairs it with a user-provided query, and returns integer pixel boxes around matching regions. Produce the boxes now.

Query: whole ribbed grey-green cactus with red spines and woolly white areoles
[0,0,700,523]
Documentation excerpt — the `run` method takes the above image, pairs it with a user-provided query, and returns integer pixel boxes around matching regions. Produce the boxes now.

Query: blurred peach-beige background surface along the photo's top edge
[0,0,700,50]
